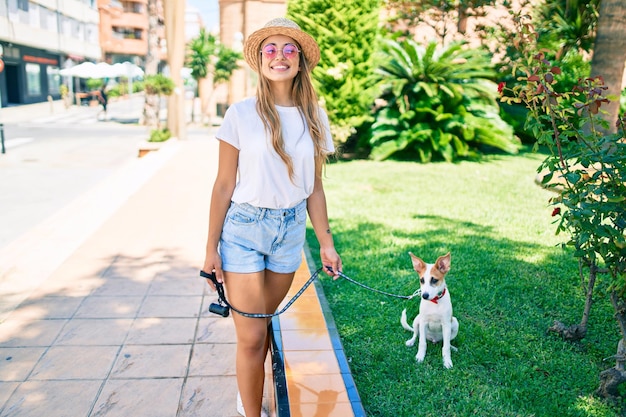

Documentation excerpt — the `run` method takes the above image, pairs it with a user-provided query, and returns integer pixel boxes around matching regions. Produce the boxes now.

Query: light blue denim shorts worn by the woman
[219,200,306,274]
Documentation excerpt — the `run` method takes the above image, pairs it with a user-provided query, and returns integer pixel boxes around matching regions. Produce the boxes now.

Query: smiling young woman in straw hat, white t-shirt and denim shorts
[203,18,342,417]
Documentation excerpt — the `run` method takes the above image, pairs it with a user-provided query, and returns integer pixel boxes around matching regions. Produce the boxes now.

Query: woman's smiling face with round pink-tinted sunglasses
[261,35,300,82]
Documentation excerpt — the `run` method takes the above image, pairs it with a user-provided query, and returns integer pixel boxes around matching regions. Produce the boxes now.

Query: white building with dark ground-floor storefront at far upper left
[0,0,101,107]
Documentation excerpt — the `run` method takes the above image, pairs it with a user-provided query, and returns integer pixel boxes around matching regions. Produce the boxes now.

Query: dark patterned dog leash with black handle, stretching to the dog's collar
[200,266,422,319]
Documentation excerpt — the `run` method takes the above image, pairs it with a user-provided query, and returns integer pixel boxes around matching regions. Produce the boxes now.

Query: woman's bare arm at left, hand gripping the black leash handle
[202,141,239,286]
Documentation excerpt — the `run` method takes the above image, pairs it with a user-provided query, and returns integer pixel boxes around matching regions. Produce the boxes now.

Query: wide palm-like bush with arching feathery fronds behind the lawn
[370,39,520,162]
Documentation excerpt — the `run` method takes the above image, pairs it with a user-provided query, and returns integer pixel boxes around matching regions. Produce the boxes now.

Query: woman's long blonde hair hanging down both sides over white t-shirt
[256,50,328,181]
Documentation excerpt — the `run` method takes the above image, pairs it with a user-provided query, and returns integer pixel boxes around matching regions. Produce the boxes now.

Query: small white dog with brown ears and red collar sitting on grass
[400,252,459,368]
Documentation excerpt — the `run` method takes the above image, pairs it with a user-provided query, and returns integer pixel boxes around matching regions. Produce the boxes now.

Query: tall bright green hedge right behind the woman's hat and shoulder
[288,0,380,144]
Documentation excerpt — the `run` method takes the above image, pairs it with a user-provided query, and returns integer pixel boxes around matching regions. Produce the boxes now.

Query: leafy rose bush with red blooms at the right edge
[503,12,626,398]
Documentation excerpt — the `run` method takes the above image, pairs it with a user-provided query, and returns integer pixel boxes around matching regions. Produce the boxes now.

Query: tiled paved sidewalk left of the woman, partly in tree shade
[0,128,258,417]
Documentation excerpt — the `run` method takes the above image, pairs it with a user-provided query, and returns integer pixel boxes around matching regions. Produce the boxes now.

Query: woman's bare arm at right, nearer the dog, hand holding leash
[307,175,342,279]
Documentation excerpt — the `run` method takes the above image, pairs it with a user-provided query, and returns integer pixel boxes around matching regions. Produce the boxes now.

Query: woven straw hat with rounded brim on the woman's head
[243,17,320,70]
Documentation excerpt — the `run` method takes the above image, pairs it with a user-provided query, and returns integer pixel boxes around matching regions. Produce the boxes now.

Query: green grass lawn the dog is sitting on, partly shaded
[307,150,619,417]
